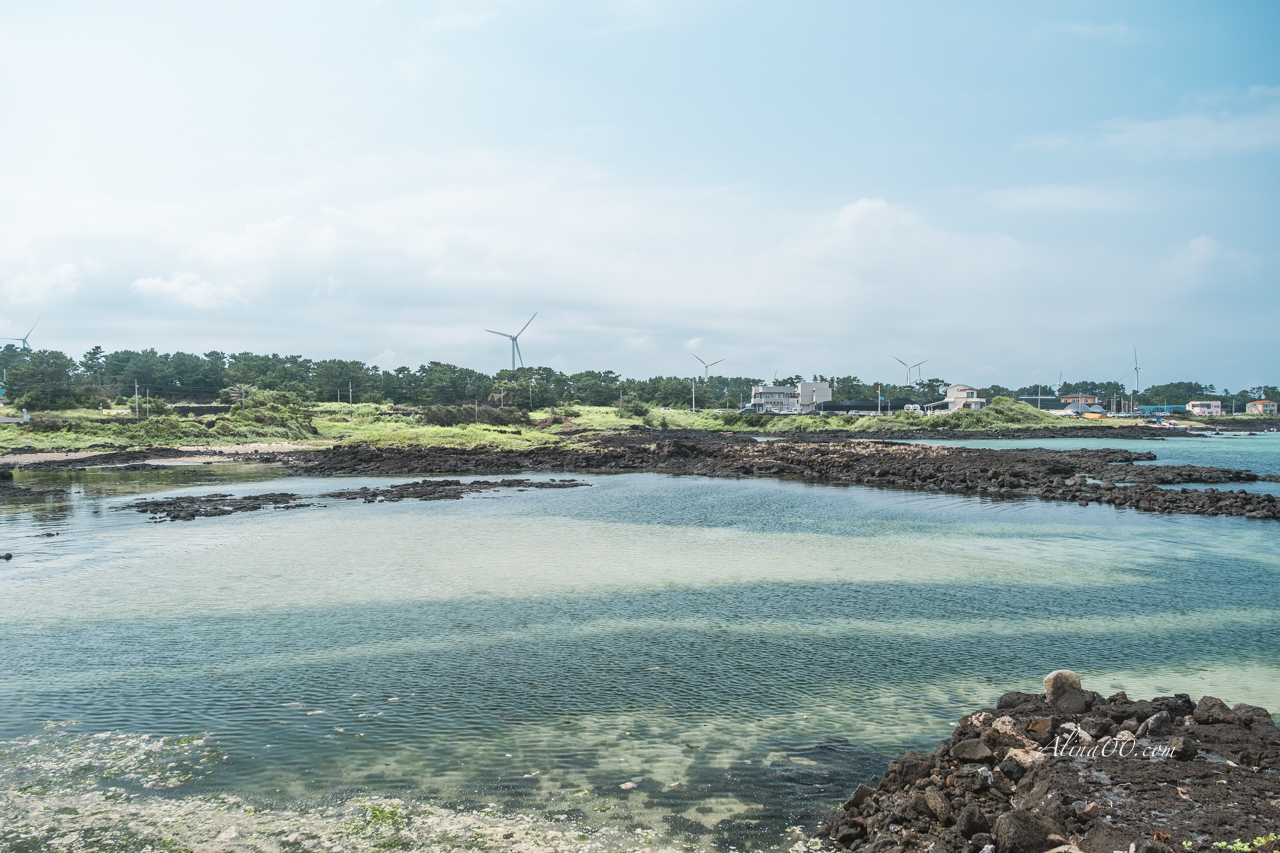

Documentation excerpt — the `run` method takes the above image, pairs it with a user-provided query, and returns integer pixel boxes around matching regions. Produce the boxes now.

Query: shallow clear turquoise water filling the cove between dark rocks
[0,461,1280,848]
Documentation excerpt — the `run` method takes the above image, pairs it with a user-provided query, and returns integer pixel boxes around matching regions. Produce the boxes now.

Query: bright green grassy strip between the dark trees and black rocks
[0,398,1218,450]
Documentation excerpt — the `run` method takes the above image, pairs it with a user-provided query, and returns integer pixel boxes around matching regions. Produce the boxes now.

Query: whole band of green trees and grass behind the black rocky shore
[0,345,1280,450]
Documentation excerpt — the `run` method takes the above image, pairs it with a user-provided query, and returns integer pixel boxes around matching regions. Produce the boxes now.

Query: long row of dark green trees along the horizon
[0,345,1280,411]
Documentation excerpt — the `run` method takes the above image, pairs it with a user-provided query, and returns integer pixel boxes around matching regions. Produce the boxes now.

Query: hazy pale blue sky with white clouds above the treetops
[0,0,1280,389]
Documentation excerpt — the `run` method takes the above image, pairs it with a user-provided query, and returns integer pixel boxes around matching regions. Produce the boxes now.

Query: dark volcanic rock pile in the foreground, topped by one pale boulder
[818,670,1280,853]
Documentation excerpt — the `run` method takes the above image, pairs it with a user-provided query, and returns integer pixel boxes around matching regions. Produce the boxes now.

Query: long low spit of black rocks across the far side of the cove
[260,430,1280,519]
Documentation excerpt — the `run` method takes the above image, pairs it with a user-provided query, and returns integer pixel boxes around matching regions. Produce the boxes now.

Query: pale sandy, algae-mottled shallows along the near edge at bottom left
[0,722,819,853]
